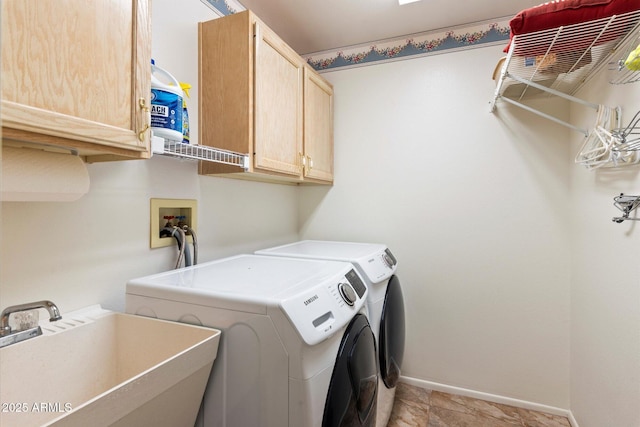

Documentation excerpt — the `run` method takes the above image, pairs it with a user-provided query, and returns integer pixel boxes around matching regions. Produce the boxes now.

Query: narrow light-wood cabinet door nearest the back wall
[304,68,333,182]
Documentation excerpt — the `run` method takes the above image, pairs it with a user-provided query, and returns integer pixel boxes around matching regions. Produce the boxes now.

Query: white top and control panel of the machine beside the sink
[126,255,368,345]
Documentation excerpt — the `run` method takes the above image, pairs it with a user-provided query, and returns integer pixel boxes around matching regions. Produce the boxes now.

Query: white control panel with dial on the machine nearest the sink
[280,264,368,345]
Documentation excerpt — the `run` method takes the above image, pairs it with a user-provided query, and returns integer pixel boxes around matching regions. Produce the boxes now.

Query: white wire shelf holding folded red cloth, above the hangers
[491,10,640,135]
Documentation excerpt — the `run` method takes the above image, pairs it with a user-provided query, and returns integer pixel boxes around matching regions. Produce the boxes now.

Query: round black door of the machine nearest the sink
[322,314,378,427]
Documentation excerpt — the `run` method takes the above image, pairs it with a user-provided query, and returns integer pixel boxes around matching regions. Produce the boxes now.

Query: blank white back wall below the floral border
[300,47,570,408]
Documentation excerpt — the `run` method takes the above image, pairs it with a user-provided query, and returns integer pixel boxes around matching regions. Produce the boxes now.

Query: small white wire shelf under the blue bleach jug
[151,136,249,171]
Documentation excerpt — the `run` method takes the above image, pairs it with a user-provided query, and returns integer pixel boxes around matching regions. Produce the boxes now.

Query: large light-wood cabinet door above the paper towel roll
[2,0,151,157]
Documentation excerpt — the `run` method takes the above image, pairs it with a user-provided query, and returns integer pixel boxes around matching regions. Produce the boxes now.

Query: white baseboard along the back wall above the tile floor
[400,376,579,427]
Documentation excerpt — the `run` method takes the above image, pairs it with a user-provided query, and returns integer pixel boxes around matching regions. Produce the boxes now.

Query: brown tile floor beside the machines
[387,383,571,427]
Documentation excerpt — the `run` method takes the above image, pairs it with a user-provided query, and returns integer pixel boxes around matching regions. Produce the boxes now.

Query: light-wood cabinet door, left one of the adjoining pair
[254,22,304,176]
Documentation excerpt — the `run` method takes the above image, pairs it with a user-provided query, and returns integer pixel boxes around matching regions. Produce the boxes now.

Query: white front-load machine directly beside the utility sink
[126,255,378,427]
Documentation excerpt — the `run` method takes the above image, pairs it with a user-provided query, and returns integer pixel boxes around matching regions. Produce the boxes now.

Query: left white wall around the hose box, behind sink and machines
[0,0,298,315]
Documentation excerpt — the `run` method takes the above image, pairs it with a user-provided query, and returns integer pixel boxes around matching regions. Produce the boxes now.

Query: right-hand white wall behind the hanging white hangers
[570,74,640,427]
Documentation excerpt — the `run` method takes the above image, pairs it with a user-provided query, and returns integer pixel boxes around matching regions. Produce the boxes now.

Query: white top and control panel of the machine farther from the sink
[256,240,398,283]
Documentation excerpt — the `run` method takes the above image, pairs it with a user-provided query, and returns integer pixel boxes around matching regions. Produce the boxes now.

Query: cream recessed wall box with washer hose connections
[150,199,198,248]
